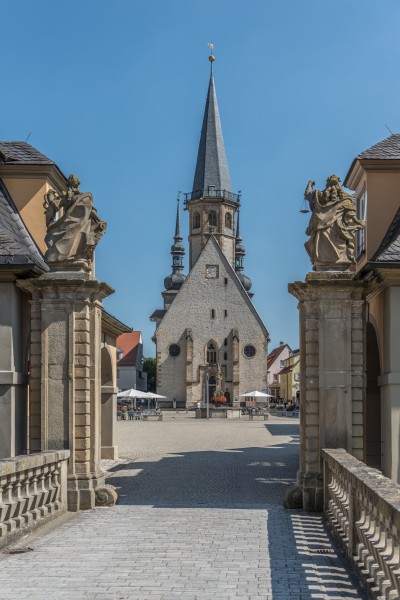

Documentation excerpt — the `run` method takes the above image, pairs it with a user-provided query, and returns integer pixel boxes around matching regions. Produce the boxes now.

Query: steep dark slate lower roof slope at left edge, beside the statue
[0,180,49,271]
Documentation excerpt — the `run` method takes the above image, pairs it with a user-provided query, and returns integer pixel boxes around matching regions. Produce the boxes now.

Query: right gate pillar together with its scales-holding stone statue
[286,175,368,511]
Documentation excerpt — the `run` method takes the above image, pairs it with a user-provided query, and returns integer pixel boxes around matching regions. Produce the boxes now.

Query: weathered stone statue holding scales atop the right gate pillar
[304,175,365,271]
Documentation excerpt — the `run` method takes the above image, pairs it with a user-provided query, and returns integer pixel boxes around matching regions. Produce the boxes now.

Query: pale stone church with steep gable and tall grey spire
[150,55,269,408]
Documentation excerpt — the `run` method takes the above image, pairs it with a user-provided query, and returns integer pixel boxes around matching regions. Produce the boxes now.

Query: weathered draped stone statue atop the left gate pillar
[44,175,106,265]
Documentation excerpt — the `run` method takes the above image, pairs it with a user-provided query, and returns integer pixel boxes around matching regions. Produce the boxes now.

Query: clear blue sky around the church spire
[0,0,400,356]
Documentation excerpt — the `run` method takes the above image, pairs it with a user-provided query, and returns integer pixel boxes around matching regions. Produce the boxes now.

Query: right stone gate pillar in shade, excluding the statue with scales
[288,272,367,511]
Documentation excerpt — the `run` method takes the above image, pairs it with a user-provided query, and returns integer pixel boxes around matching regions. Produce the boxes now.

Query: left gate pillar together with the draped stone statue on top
[19,175,116,511]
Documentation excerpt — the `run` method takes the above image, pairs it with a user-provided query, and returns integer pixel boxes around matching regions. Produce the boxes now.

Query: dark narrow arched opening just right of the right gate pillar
[365,323,382,469]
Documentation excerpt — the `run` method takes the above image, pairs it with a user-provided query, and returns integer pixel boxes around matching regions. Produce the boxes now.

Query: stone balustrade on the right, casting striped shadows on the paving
[322,449,400,600]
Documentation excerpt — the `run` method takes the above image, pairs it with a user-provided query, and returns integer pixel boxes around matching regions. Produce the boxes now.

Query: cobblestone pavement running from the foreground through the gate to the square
[0,413,365,600]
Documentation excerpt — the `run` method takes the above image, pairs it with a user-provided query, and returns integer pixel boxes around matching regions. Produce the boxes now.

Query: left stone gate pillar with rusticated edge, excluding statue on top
[20,271,113,510]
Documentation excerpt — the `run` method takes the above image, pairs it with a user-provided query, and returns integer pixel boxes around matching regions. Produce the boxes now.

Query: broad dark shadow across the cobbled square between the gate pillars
[108,424,299,508]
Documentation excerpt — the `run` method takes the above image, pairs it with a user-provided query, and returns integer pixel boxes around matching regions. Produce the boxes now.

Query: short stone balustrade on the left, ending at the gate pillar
[0,450,70,547]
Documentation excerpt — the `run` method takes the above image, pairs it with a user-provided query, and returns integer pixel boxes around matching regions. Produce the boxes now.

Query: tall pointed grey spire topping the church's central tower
[193,49,231,195]
